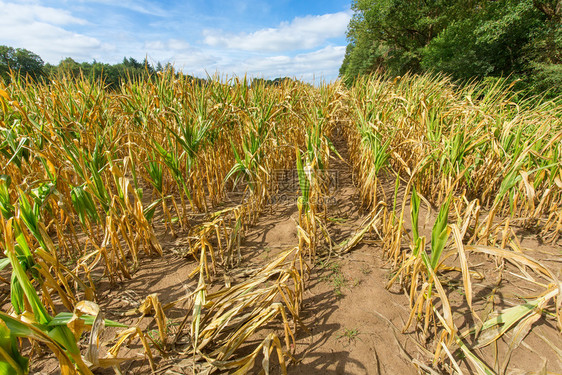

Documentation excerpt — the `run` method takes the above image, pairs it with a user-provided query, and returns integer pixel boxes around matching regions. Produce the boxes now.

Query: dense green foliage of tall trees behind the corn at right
[340,0,562,92]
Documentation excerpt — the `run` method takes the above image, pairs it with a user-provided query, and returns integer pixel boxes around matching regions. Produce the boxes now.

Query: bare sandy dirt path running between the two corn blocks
[289,134,415,375]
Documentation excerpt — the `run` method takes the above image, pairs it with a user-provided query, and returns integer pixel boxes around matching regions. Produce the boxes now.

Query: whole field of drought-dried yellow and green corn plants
[0,72,562,374]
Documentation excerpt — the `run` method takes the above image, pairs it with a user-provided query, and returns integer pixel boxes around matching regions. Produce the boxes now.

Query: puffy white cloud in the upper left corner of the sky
[0,1,105,63]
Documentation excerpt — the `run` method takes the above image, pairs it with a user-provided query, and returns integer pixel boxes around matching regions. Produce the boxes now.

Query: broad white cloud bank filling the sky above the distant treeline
[0,0,351,81]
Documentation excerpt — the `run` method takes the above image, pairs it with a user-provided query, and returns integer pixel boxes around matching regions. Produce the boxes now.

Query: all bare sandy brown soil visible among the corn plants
[12,134,562,375]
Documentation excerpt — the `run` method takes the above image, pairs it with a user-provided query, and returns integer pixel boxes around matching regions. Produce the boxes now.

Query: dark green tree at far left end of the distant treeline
[0,46,45,82]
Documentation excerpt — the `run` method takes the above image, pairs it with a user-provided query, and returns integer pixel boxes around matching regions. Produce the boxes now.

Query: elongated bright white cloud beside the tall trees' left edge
[203,12,351,51]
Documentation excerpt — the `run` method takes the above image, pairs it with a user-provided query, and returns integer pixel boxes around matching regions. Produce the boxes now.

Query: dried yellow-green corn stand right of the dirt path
[344,76,562,374]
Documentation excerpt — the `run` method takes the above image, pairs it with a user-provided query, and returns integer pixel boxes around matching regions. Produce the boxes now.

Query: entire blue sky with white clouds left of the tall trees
[0,0,352,82]
